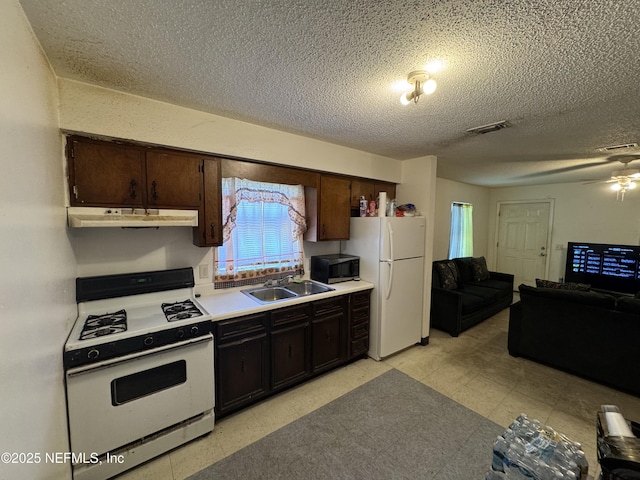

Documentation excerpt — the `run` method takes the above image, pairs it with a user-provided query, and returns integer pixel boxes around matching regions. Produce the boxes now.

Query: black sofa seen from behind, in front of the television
[508,285,640,396]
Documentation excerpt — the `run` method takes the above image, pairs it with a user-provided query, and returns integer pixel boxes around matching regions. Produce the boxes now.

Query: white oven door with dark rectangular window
[66,334,214,456]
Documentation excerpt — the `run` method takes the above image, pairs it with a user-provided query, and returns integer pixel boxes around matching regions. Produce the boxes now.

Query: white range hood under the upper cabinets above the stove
[67,207,198,228]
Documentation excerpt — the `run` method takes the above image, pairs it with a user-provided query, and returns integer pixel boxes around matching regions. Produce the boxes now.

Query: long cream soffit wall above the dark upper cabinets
[59,78,401,183]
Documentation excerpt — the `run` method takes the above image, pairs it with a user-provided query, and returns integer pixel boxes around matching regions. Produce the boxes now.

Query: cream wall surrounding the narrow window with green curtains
[433,178,495,261]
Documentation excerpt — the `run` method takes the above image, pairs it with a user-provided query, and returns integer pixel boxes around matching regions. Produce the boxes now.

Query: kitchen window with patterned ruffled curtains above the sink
[214,178,306,288]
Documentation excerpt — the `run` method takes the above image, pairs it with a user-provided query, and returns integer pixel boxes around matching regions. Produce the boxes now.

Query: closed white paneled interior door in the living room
[496,201,551,288]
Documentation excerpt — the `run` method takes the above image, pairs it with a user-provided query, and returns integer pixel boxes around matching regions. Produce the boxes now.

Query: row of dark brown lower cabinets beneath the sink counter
[214,291,369,417]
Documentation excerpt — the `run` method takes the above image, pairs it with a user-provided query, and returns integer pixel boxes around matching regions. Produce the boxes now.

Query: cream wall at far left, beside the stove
[0,0,76,479]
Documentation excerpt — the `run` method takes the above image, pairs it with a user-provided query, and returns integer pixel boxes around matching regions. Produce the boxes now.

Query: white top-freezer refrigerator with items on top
[341,217,426,360]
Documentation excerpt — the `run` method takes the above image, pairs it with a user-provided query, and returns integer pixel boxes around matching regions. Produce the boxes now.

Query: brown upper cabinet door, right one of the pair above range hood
[147,150,202,209]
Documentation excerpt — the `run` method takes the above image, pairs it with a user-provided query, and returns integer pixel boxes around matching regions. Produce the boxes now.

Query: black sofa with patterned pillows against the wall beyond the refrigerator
[431,257,513,337]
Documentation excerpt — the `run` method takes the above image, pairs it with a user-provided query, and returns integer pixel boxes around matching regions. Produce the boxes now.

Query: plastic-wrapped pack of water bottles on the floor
[486,414,589,480]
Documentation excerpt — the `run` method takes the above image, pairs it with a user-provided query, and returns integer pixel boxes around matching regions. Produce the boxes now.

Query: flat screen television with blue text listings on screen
[564,242,640,293]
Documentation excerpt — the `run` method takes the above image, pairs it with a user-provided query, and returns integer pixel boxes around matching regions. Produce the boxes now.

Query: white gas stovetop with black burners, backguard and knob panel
[63,268,212,369]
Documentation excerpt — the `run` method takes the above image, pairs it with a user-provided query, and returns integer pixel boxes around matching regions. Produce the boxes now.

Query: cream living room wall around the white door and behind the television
[488,183,640,281]
